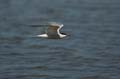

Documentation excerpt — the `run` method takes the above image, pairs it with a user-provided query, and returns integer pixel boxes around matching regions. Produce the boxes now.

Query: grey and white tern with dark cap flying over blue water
[37,22,67,39]
